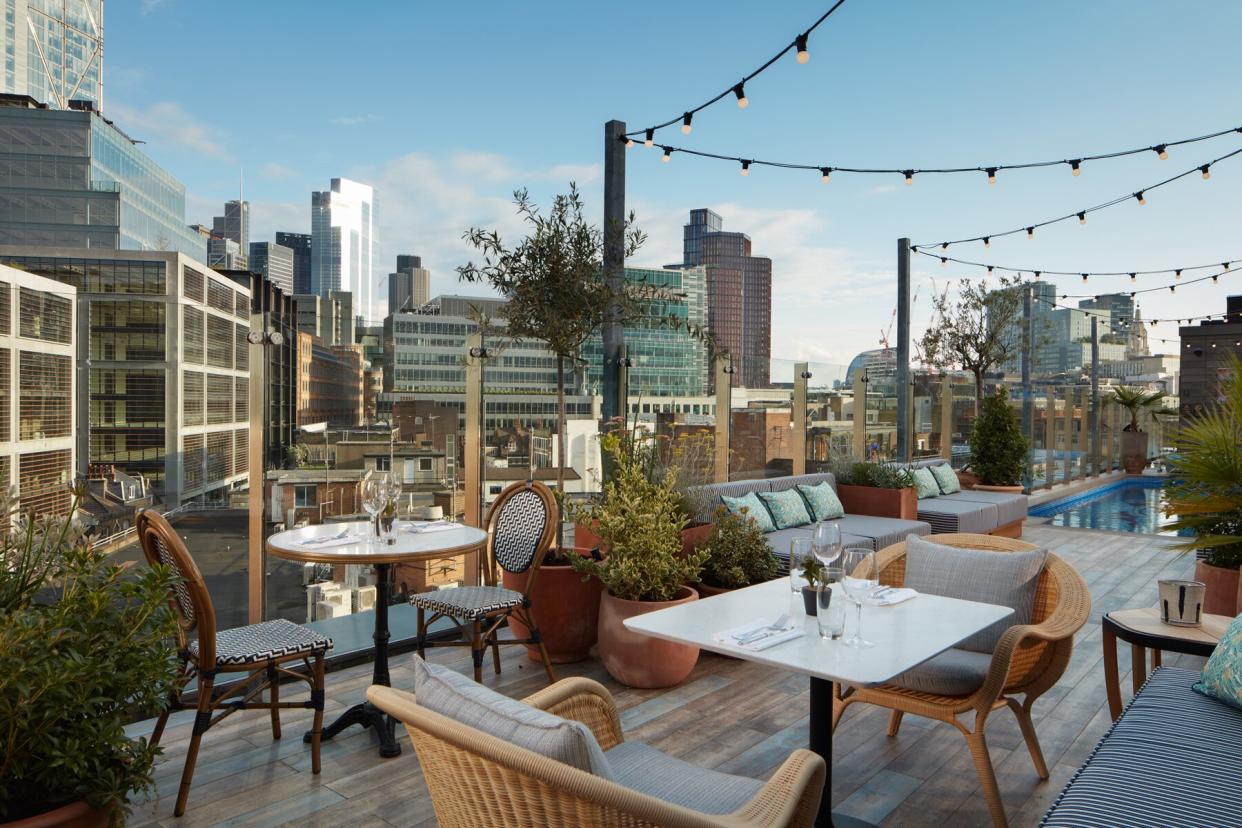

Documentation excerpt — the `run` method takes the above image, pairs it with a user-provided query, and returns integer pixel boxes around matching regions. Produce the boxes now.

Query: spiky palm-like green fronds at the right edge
[1165,355,1242,569]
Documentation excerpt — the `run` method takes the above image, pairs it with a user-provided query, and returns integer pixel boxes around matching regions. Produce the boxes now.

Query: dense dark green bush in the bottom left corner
[0,491,178,824]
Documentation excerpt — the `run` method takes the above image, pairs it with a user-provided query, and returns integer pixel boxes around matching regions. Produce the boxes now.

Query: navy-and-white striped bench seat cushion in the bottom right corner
[1040,667,1242,828]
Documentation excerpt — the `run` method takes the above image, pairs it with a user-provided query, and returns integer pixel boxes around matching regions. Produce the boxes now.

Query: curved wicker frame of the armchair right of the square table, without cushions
[832,533,1090,826]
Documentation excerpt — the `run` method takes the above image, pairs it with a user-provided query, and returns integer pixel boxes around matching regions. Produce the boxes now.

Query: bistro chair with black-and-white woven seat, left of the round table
[135,510,332,817]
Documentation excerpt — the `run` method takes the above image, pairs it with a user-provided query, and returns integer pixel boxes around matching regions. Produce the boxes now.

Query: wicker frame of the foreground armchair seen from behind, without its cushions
[366,678,826,828]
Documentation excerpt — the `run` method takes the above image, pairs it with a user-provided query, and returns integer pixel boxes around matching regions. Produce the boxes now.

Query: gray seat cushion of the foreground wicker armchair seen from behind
[605,742,763,814]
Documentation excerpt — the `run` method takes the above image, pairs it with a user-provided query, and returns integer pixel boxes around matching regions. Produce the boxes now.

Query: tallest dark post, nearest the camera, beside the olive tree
[602,120,625,431]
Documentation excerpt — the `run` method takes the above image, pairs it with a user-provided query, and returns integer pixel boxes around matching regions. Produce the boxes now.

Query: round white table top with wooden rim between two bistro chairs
[267,520,487,565]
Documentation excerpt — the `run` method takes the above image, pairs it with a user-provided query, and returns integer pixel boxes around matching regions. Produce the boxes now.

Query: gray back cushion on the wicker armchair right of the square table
[904,536,1048,654]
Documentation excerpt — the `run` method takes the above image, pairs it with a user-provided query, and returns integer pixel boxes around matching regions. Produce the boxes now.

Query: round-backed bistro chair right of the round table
[410,480,560,683]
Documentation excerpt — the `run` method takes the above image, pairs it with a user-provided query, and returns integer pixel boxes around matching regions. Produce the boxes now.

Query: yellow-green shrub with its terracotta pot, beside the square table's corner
[566,433,707,688]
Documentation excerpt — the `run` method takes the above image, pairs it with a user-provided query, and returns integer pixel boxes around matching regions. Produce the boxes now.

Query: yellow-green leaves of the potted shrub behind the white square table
[566,433,708,601]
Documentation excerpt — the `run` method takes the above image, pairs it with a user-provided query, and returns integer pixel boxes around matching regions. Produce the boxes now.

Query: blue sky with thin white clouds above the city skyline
[103,0,1242,379]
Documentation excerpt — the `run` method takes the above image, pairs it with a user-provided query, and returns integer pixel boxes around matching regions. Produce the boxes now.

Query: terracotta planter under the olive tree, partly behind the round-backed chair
[503,549,604,664]
